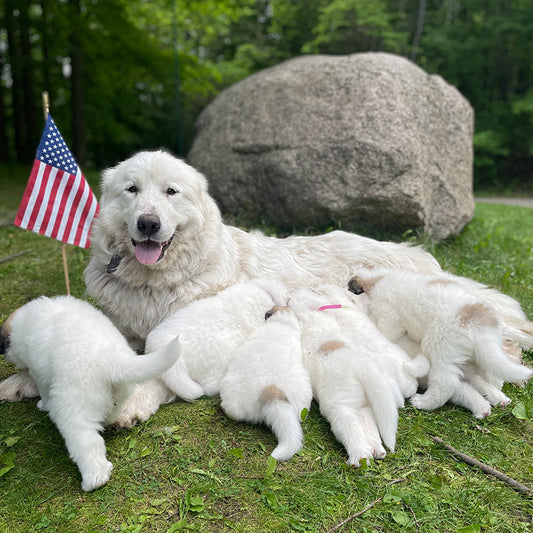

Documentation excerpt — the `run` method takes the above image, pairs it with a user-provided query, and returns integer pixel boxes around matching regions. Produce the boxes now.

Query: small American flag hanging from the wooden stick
[15,115,98,248]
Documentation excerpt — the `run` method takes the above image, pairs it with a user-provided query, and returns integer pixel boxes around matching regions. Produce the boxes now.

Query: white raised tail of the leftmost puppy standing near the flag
[117,337,180,383]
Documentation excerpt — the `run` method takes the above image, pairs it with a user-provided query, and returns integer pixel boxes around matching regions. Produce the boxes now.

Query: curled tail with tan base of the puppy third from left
[260,385,303,461]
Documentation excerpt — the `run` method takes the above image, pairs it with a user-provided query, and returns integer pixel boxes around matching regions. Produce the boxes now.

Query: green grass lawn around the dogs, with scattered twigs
[0,164,533,533]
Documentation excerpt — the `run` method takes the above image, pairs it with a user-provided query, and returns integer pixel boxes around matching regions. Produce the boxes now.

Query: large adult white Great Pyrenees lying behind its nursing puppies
[3,151,531,428]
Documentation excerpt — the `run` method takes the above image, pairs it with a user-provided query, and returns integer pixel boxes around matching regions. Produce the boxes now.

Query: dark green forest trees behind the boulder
[0,0,533,192]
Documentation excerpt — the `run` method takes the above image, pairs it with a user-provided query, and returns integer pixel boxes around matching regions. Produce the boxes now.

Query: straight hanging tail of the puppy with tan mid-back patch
[360,364,403,451]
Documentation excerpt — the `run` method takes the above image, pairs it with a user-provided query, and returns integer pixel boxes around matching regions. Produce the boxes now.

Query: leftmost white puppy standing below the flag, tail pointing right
[2,296,179,491]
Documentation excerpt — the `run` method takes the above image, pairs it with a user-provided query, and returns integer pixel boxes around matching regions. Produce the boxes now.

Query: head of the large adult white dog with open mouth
[94,151,220,271]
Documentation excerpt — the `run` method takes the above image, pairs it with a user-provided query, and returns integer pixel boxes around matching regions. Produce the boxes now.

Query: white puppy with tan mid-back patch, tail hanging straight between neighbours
[290,289,403,467]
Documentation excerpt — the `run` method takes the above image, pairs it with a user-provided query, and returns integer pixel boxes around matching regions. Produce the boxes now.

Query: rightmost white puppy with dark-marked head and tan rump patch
[349,268,533,418]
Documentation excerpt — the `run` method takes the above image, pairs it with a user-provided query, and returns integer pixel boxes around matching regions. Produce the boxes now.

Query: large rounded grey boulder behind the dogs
[188,53,474,239]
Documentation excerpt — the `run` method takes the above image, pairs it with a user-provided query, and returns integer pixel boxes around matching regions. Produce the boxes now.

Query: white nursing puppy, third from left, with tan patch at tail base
[220,307,313,461]
